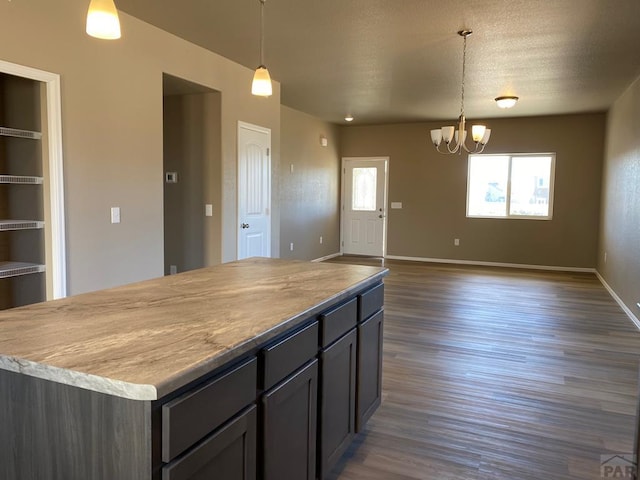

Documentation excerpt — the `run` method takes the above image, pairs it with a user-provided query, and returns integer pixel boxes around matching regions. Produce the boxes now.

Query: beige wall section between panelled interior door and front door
[280,107,340,260]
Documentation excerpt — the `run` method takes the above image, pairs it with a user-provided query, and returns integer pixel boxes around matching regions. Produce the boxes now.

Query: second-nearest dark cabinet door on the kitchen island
[262,360,318,480]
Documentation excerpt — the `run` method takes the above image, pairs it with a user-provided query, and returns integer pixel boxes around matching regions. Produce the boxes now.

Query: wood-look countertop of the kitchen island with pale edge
[0,258,387,400]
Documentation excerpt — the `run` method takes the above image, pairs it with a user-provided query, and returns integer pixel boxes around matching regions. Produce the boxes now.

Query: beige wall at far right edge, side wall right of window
[598,77,640,318]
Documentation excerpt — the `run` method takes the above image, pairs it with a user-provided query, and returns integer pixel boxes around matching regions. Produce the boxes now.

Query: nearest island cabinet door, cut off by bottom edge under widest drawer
[162,406,257,480]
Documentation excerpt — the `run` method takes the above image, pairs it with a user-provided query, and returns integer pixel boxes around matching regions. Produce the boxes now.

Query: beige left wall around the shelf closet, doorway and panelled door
[0,0,280,294]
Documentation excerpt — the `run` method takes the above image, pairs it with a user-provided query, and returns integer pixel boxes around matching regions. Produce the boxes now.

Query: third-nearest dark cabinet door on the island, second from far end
[319,328,358,478]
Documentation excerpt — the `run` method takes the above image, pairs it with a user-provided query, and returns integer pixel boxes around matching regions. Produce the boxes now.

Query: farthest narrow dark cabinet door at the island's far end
[356,311,384,432]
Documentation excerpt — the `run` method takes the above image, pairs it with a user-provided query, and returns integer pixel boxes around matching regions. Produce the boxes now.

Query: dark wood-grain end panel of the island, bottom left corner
[0,370,151,480]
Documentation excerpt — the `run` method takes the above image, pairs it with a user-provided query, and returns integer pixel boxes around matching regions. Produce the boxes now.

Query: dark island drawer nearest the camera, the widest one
[162,357,258,462]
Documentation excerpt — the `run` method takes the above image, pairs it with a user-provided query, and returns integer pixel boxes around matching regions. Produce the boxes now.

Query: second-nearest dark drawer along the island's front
[262,322,318,390]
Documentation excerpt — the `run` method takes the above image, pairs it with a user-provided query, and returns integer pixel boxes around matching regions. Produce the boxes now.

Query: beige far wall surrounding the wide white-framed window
[341,114,605,268]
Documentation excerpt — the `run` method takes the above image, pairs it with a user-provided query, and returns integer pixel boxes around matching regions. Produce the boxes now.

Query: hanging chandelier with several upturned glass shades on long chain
[431,30,491,154]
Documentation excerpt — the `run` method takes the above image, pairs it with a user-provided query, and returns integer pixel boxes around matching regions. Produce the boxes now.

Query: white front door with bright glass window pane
[341,158,389,257]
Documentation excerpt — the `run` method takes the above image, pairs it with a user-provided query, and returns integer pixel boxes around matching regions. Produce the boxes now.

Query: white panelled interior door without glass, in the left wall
[238,122,271,259]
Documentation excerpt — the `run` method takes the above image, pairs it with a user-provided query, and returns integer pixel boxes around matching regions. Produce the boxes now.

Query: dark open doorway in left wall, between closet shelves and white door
[162,74,222,275]
